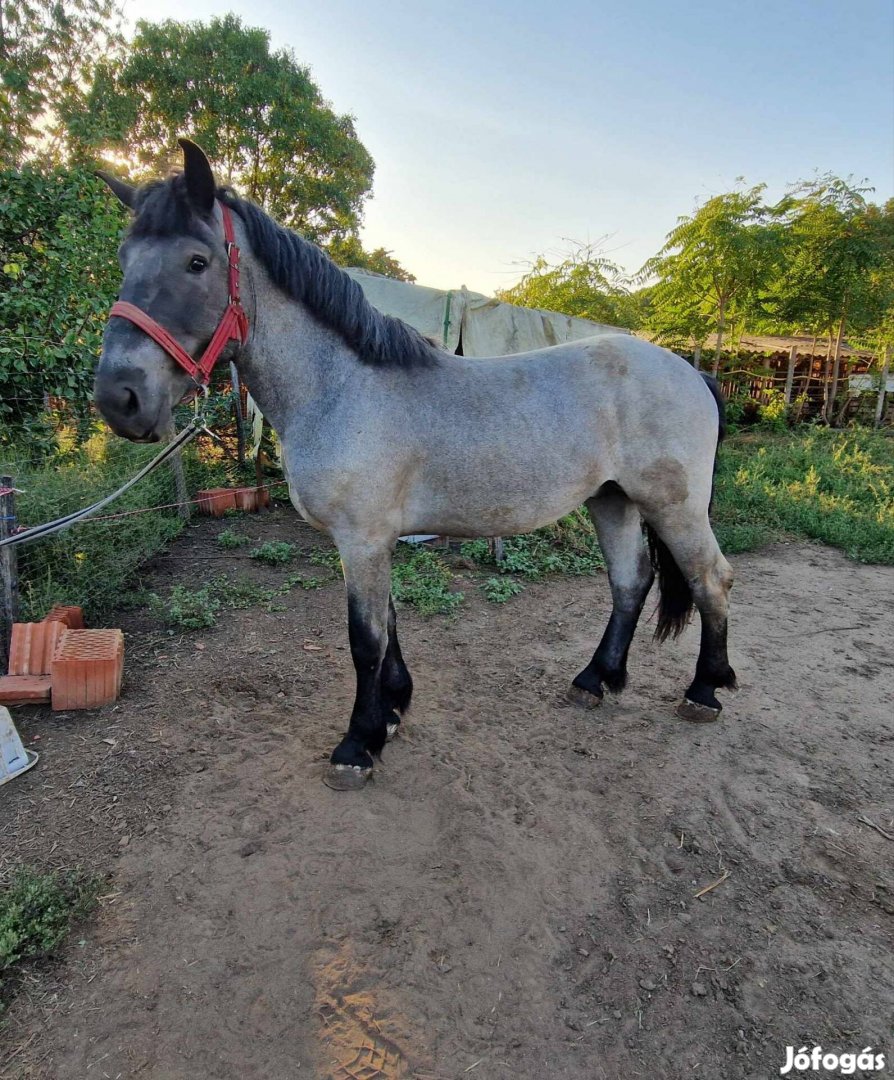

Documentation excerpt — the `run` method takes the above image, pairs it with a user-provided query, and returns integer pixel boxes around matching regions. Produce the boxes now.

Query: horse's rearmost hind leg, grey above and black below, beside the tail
[650,513,736,724]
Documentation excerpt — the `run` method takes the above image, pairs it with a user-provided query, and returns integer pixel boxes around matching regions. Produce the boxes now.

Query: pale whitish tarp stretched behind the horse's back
[348,268,629,356]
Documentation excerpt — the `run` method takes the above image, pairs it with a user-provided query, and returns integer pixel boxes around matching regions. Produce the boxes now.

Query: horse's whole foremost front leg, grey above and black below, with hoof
[324,537,396,791]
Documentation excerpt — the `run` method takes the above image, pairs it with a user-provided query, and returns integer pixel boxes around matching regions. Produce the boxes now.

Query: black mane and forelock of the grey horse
[131,173,441,367]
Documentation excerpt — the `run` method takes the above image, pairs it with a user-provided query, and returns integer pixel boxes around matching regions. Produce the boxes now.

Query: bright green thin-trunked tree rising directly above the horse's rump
[639,184,782,375]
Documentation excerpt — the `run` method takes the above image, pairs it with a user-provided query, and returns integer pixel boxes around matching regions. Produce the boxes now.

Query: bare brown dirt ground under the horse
[0,509,894,1080]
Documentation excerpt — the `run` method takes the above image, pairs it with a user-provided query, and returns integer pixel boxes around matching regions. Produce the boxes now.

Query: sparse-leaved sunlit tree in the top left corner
[0,0,120,168]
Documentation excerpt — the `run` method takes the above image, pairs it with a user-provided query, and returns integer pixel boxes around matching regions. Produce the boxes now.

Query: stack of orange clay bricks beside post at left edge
[0,605,124,710]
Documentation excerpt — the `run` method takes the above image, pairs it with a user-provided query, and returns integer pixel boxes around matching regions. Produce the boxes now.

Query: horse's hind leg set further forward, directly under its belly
[569,485,653,708]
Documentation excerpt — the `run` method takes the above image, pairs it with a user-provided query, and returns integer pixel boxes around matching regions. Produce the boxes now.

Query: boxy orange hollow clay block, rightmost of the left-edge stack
[52,630,124,710]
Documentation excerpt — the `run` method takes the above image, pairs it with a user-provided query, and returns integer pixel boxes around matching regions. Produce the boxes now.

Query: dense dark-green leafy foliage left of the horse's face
[0,165,125,443]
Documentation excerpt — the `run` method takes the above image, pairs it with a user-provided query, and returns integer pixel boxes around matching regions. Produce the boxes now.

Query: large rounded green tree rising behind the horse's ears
[67,15,374,241]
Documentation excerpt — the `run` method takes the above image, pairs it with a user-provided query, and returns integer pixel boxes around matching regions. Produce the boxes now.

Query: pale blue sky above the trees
[125,0,894,294]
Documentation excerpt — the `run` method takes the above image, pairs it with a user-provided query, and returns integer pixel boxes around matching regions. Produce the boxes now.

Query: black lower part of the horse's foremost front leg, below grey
[330,597,389,768]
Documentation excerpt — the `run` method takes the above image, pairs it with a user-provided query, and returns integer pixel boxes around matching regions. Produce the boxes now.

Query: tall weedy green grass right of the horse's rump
[714,428,894,565]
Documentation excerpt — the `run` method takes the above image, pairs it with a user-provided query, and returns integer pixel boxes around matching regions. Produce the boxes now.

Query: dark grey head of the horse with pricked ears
[94,139,241,442]
